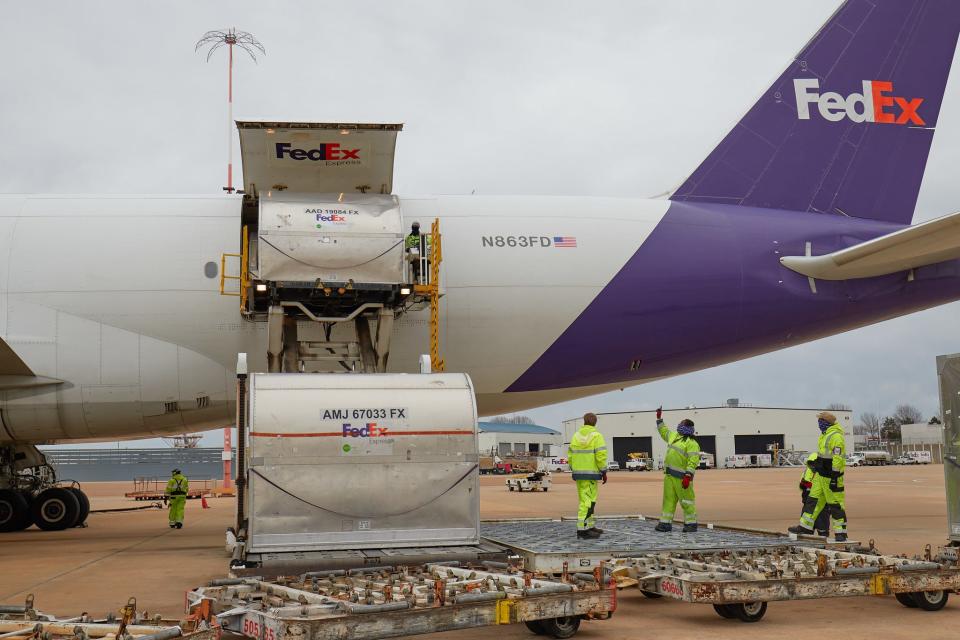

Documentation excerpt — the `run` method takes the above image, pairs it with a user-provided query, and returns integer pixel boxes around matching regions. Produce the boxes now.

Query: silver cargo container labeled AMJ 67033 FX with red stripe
[245,373,480,553]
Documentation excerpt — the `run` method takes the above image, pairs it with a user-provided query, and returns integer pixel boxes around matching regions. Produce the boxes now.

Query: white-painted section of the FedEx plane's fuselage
[0,196,669,443]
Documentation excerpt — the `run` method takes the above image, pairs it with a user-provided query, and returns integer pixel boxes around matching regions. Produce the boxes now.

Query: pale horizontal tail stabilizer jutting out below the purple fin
[780,212,960,280]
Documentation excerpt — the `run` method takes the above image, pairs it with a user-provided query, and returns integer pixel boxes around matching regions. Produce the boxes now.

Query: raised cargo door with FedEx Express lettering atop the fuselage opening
[237,120,403,197]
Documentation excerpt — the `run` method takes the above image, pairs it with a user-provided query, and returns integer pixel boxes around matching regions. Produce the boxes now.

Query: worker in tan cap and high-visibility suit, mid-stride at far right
[787,411,847,542]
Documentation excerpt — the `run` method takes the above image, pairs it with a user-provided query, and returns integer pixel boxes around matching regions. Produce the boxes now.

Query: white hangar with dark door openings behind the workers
[563,400,853,469]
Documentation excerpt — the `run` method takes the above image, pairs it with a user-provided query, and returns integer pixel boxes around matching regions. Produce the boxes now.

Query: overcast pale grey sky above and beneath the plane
[0,0,960,450]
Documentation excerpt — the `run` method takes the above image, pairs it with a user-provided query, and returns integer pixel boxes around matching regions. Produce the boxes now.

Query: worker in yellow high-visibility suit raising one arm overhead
[656,407,700,533]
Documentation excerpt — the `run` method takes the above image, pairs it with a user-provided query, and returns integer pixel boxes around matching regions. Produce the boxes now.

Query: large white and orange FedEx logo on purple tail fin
[793,78,926,125]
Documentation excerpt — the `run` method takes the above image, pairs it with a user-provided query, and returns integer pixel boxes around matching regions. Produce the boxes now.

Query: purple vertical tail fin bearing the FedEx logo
[671,0,960,224]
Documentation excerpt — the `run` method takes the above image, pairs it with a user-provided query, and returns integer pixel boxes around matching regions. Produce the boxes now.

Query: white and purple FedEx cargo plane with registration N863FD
[0,0,960,528]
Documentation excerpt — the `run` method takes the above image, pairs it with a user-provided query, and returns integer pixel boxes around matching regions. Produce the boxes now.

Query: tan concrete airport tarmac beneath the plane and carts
[0,465,960,640]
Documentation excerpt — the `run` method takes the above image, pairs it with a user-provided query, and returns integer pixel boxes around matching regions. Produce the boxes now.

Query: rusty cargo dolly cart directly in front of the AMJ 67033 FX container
[187,562,617,640]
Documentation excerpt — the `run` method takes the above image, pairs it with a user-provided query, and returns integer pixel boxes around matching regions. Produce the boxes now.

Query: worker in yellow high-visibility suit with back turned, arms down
[567,413,607,539]
